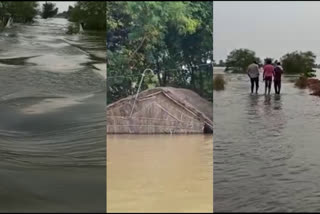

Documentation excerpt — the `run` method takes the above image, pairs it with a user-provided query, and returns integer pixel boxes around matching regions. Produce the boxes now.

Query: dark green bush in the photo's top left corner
[0,1,38,23]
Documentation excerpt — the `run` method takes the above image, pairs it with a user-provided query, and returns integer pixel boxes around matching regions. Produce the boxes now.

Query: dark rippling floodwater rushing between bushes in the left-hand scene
[0,19,106,212]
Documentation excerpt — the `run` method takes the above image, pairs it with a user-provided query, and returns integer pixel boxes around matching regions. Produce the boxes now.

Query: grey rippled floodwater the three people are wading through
[213,69,320,212]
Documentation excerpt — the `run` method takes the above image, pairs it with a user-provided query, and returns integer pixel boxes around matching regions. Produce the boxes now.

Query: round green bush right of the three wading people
[281,51,316,77]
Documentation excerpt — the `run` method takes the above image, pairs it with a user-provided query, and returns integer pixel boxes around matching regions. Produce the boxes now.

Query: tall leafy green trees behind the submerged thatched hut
[107,1,212,103]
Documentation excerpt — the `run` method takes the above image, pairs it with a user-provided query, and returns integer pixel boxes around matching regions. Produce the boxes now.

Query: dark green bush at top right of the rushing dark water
[68,1,106,31]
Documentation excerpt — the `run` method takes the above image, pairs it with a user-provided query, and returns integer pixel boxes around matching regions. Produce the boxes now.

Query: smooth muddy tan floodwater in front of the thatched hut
[107,135,213,213]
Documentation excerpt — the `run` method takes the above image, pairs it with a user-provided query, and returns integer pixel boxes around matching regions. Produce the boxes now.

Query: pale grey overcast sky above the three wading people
[213,1,320,63]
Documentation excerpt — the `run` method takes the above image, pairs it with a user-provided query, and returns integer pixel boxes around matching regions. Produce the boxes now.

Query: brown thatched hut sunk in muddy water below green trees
[107,87,213,134]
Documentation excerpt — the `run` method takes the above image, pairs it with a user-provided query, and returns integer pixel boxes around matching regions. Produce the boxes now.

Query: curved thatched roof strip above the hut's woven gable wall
[107,87,213,132]
